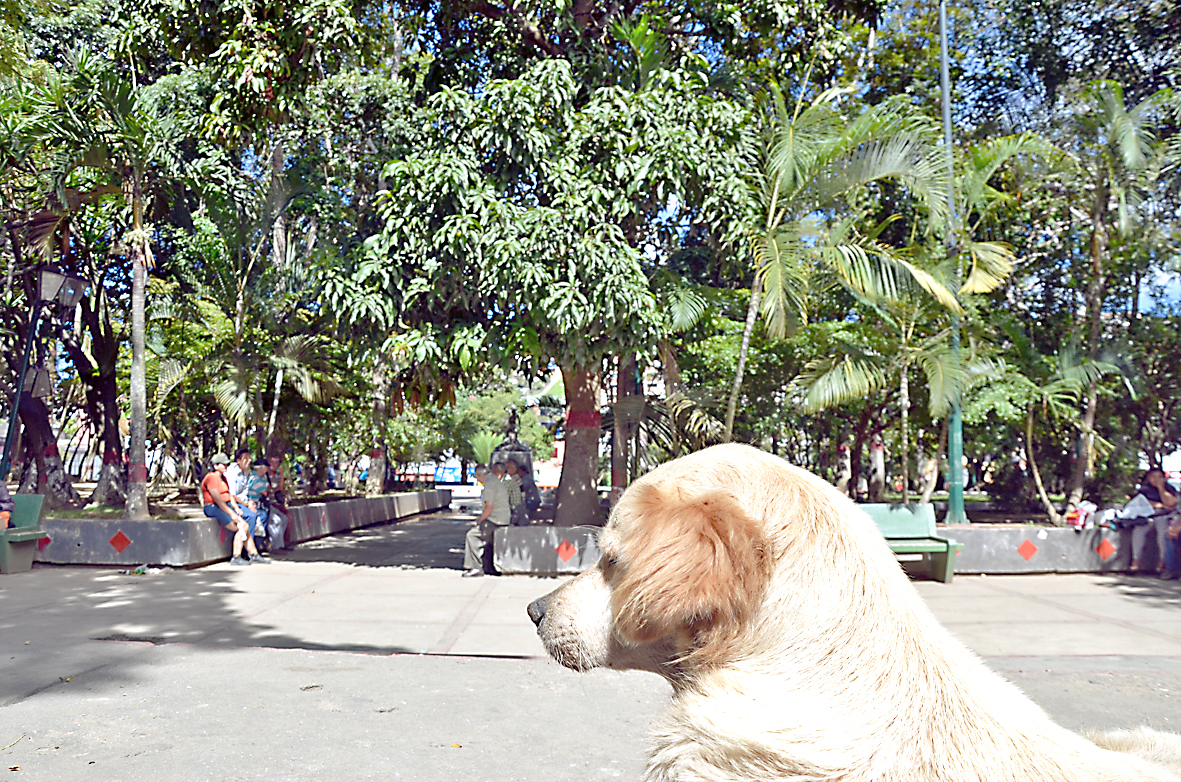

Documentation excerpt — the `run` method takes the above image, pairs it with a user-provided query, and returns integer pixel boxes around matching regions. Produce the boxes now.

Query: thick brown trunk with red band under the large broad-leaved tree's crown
[554,366,602,527]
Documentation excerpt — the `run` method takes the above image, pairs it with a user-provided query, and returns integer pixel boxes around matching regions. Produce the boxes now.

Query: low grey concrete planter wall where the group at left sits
[37,489,451,567]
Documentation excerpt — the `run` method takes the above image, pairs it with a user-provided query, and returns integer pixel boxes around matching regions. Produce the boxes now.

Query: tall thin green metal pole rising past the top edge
[939,0,968,524]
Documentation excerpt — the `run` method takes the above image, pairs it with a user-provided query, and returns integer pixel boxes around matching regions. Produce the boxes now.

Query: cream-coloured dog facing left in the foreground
[529,445,1181,782]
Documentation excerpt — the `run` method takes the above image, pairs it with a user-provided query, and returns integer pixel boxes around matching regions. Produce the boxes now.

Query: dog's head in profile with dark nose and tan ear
[529,447,772,676]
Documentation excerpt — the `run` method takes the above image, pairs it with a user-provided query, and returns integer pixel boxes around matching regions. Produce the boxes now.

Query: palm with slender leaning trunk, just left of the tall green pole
[725,85,959,439]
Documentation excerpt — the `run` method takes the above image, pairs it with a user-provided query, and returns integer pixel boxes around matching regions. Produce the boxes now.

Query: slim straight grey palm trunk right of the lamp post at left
[124,170,151,520]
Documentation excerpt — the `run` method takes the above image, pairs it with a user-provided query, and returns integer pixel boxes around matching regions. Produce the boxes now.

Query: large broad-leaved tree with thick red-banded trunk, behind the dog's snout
[359,51,746,521]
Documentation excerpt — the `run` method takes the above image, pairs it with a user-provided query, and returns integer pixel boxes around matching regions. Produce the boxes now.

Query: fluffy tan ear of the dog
[612,484,769,656]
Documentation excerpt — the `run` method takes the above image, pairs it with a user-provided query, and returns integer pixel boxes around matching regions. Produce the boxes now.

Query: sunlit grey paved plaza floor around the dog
[0,513,1181,782]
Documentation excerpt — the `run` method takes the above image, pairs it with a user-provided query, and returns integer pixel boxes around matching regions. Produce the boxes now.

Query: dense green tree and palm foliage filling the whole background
[0,0,1181,515]
